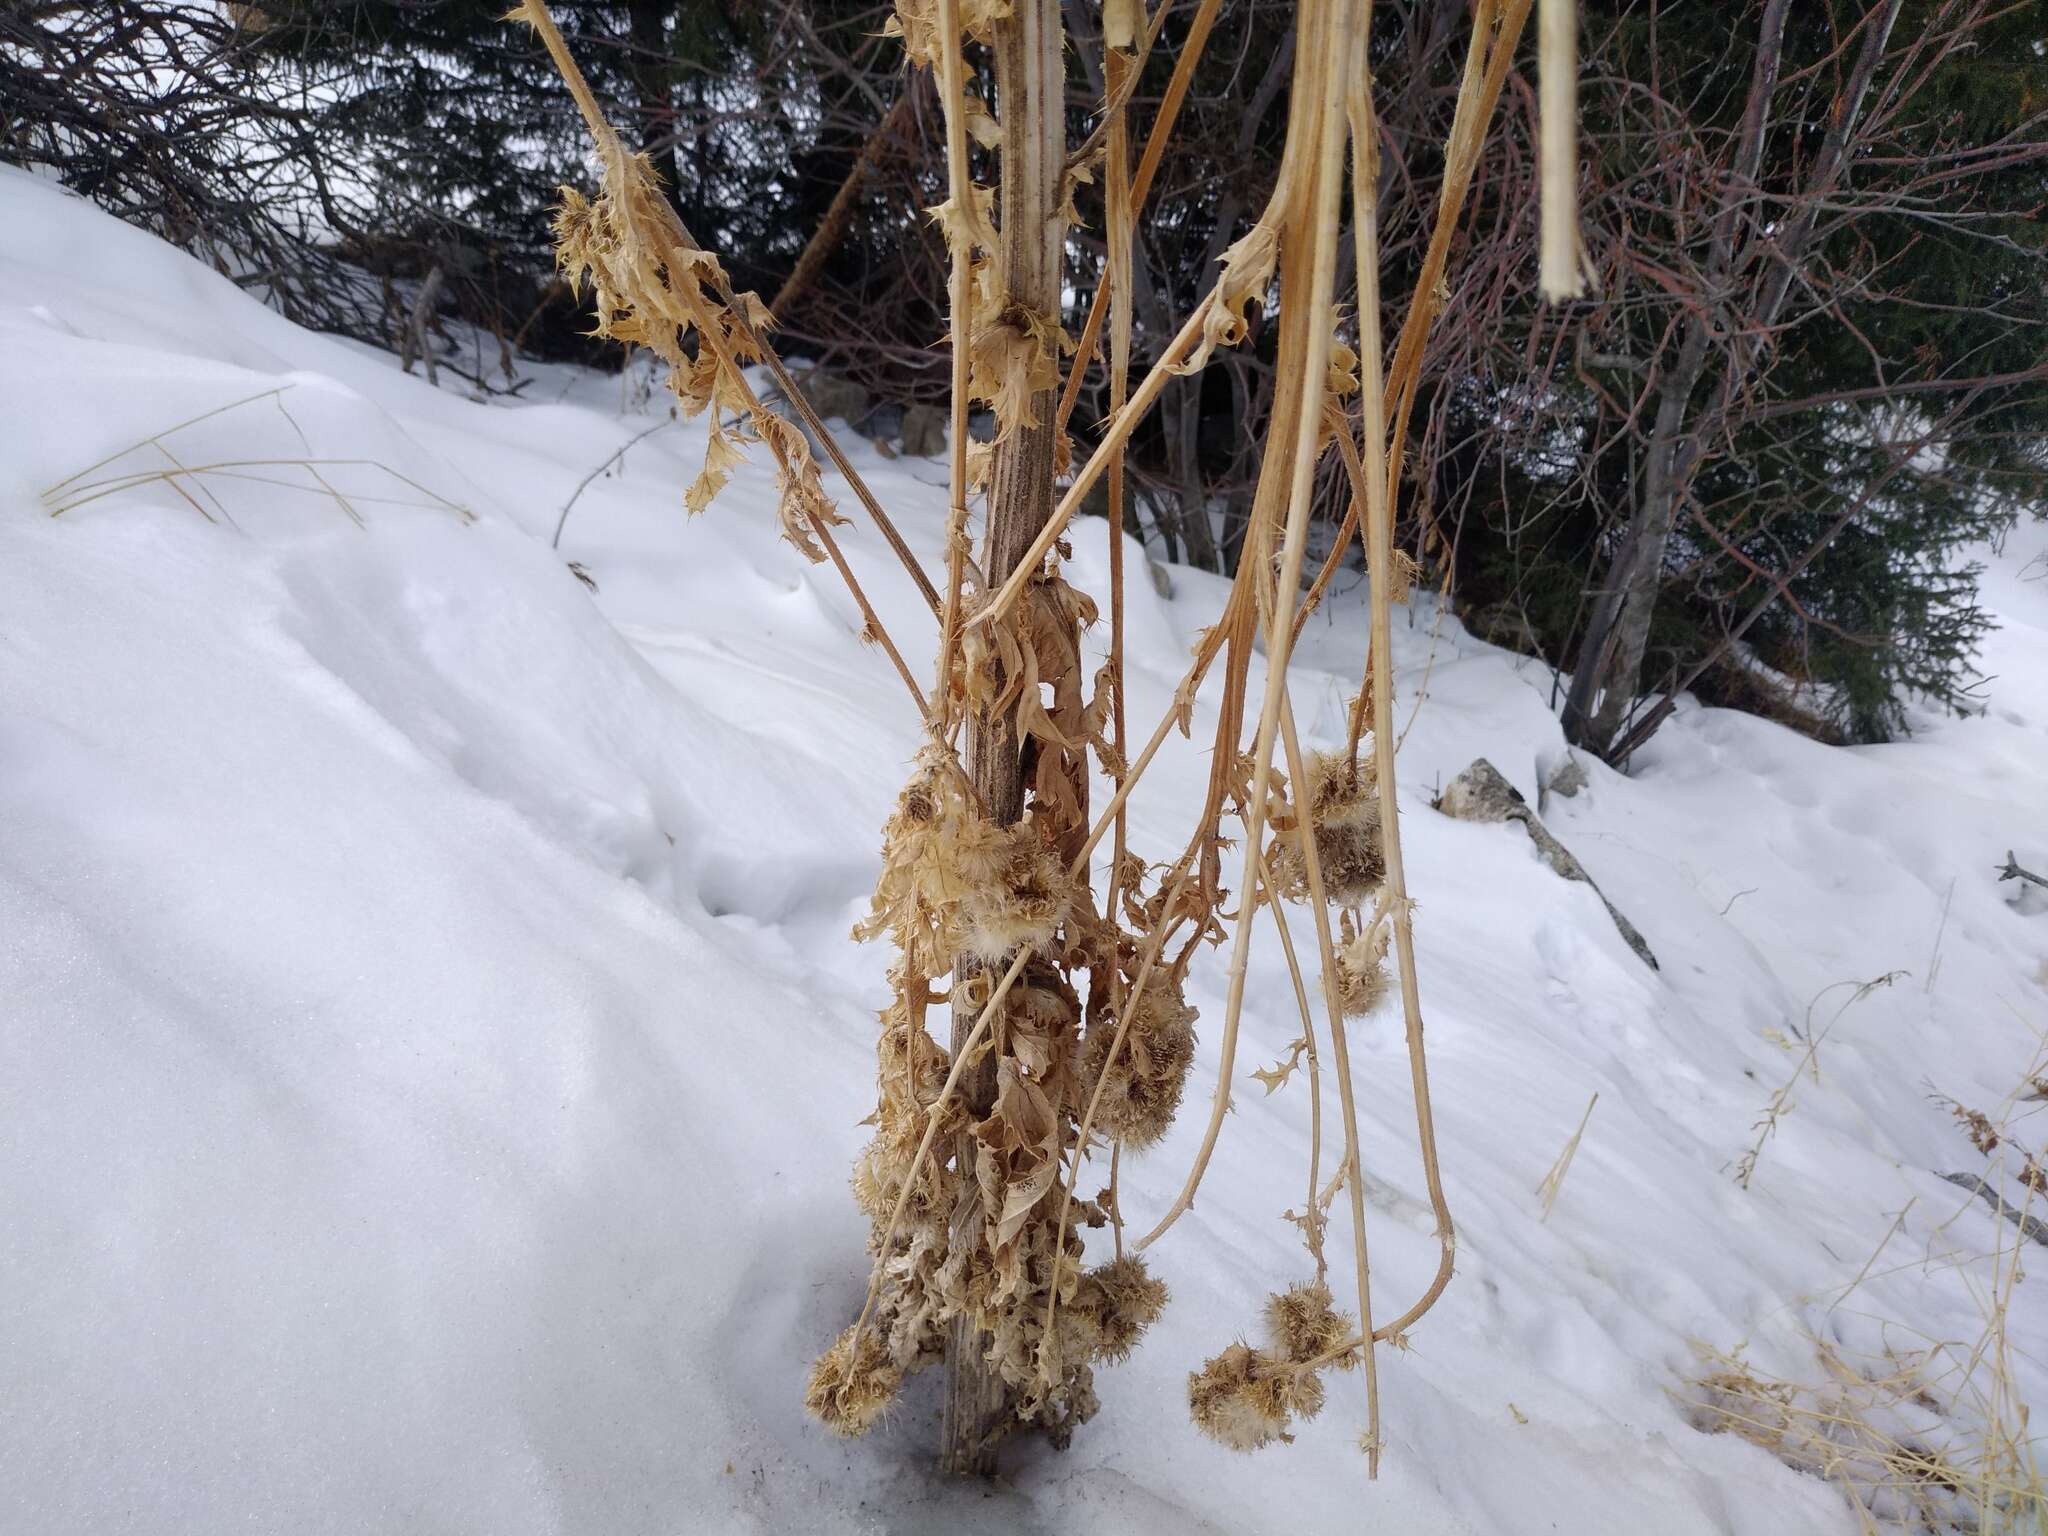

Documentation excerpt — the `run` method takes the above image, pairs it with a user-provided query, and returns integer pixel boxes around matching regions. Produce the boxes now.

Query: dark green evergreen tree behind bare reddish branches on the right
[1438,0,2048,748]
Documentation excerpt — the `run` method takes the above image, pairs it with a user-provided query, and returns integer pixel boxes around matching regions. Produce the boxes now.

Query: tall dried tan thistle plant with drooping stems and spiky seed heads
[514,0,1569,1473]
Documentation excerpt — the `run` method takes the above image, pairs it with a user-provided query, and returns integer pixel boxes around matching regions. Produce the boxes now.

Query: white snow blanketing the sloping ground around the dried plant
[0,168,2048,1536]
